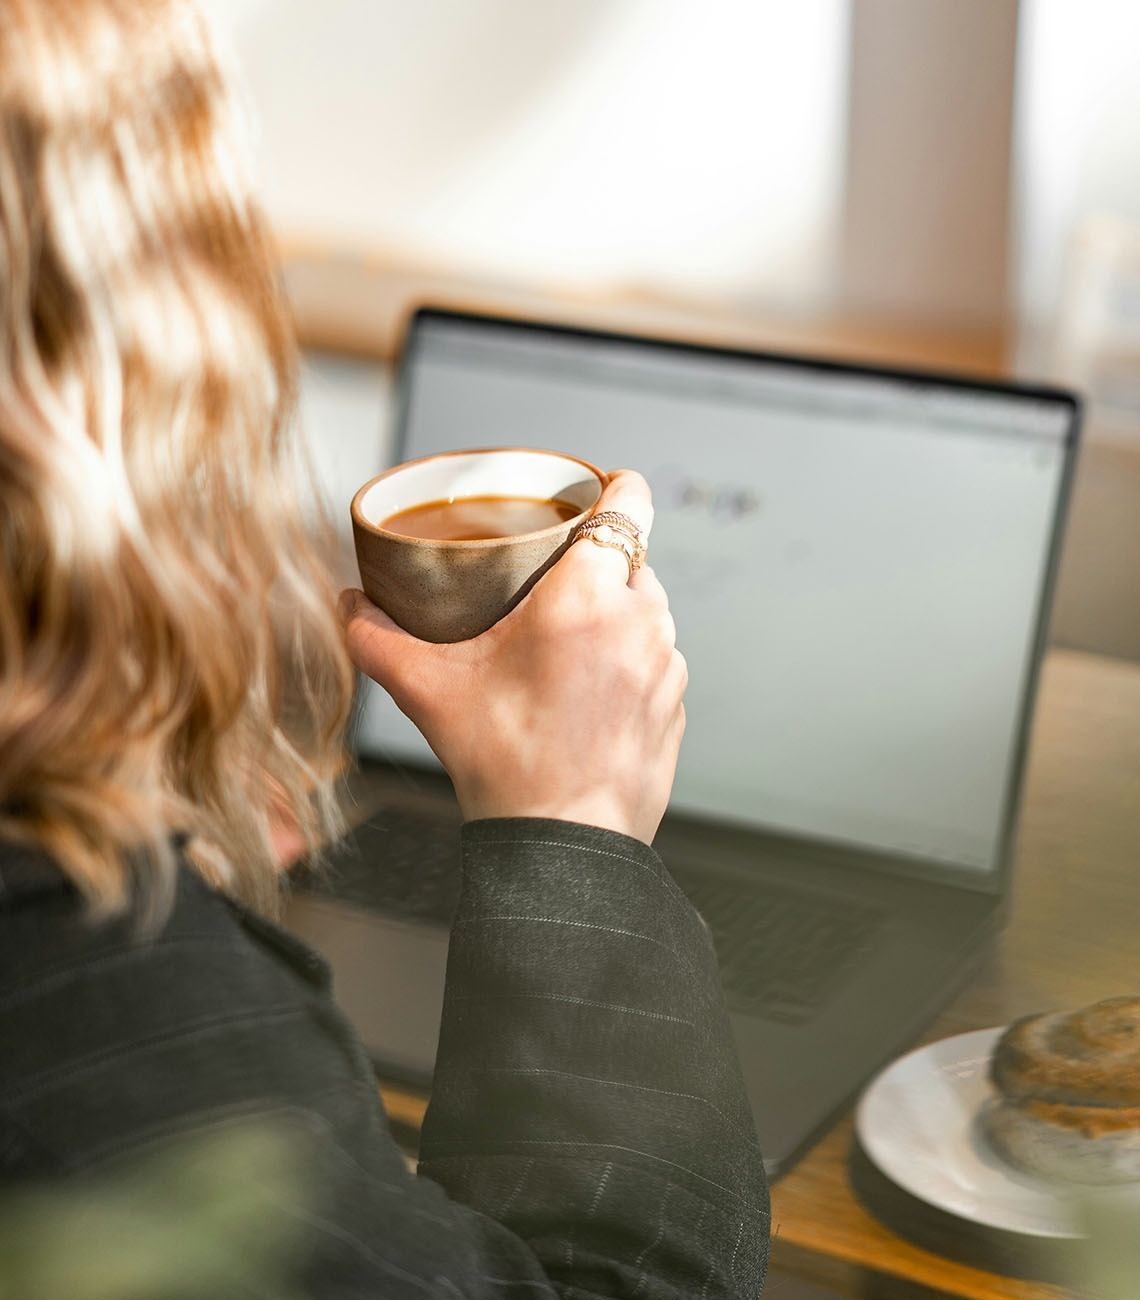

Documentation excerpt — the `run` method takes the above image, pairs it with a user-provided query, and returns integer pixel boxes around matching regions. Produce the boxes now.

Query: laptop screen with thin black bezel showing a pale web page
[357,313,1075,875]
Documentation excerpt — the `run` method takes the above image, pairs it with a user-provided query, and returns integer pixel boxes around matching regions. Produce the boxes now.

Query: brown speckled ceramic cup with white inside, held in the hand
[352,447,604,641]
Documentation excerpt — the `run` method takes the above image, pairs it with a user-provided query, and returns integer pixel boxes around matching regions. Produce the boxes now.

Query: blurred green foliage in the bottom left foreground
[0,1119,318,1300]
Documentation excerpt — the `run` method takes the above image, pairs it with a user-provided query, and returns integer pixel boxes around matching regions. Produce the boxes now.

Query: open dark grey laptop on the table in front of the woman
[282,309,1079,1177]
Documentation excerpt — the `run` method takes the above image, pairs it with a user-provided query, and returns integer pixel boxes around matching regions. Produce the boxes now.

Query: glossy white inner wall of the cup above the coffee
[359,450,602,527]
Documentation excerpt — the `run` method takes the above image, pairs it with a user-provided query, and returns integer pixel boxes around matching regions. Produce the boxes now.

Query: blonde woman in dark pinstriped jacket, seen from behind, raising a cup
[0,0,767,1297]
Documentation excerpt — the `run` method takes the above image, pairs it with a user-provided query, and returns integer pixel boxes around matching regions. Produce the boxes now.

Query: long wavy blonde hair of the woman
[0,0,352,913]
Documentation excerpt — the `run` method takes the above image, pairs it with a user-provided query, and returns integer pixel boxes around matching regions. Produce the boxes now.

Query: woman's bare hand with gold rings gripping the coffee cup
[342,471,688,844]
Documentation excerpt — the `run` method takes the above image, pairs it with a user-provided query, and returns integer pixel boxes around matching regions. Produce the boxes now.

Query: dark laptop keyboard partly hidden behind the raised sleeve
[294,807,883,1024]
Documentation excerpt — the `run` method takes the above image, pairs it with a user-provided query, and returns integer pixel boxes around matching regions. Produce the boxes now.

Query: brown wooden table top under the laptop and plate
[382,650,1140,1300]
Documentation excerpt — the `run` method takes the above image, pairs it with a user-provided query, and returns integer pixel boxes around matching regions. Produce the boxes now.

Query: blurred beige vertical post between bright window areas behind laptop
[842,0,1018,330]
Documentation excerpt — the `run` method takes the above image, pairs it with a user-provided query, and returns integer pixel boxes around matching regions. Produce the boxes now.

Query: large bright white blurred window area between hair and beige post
[220,0,850,308]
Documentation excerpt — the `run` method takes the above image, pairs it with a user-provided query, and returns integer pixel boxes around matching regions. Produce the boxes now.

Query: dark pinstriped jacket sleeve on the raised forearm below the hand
[420,819,770,1300]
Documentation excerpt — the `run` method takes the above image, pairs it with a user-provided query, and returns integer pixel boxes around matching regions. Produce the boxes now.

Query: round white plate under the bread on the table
[855,1028,1080,1239]
